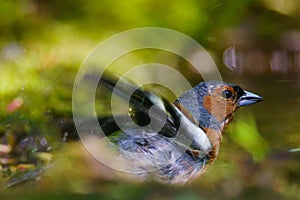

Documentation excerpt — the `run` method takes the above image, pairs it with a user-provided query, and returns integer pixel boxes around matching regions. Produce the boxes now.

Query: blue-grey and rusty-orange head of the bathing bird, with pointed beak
[176,81,262,129]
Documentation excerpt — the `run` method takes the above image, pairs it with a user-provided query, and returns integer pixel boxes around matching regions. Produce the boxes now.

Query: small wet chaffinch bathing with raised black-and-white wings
[99,76,262,184]
